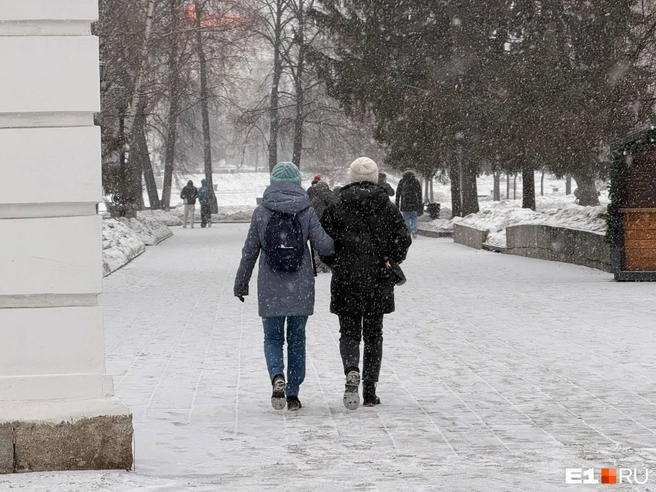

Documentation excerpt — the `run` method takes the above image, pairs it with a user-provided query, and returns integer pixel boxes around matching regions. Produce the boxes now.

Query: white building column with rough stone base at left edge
[0,0,132,473]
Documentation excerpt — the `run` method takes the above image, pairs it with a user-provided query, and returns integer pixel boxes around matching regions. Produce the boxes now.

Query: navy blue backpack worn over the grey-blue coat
[264,210,305,272]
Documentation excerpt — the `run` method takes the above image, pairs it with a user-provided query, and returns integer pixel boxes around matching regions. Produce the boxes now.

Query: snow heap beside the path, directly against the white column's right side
[102,219,146,276]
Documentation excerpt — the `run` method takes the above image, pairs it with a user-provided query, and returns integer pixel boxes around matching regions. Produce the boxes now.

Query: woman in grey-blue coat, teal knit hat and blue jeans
[234,162,334,410]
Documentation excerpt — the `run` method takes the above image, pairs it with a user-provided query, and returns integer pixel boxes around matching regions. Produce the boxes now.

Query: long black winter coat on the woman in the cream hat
[321,182,412,315]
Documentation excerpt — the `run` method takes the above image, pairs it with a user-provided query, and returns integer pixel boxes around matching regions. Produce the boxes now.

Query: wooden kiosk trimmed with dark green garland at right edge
[607,126,656,282]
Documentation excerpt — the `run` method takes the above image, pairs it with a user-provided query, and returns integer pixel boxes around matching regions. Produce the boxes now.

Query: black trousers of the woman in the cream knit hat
[339,314,383,383]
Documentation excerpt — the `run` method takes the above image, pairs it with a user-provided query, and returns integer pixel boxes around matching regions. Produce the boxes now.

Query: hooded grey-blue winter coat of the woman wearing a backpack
[234,181,335,318]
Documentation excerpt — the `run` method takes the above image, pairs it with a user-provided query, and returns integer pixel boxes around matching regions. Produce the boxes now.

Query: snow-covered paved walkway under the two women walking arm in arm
[0,224,656,492]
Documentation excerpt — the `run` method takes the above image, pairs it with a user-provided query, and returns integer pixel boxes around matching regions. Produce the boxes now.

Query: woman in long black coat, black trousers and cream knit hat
[322,157,412,410]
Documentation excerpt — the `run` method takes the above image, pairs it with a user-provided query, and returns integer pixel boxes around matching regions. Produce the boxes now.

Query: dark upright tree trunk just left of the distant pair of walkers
[162,0,180,210]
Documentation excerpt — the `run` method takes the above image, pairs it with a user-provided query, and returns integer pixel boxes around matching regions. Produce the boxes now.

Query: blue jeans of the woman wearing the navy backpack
[262,316,308,396]
